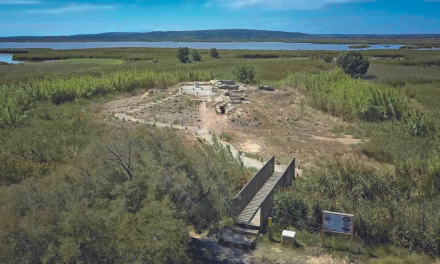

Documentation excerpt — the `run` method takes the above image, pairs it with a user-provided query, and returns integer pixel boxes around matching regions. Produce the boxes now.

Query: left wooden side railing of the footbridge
[234,155,275,215]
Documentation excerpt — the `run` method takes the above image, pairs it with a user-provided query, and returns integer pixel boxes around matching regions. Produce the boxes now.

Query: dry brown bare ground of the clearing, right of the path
[201,90,368,169]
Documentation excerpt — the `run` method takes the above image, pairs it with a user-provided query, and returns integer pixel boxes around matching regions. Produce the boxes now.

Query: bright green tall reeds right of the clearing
[282,69,408,121]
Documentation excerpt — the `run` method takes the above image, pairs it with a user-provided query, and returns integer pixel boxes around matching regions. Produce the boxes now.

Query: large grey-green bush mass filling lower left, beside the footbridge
[0,126,247,263]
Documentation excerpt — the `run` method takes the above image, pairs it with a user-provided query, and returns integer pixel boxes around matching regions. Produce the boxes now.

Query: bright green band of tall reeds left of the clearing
[0,67,213,127]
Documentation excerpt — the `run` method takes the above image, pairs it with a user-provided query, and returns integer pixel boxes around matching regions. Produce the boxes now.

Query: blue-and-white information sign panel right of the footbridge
[322,211,354,235]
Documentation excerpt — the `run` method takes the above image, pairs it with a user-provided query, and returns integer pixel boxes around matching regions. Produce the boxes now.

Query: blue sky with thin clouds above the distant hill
[0,0,440,37]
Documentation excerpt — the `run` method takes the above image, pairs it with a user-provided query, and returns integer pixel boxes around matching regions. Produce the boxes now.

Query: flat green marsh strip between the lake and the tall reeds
[0,48,440,85]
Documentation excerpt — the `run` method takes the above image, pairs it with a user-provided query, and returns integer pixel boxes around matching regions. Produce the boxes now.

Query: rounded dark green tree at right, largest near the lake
[336,51,370,77]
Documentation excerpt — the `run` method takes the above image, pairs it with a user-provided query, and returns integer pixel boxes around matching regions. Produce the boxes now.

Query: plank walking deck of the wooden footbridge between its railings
[236,171,283,228]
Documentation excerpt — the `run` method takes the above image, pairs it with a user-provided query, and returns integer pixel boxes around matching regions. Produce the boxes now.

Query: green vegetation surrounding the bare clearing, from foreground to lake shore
[0,45,440,263]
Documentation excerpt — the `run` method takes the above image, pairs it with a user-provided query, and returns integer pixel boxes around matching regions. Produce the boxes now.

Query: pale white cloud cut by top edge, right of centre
[205,0,372,10]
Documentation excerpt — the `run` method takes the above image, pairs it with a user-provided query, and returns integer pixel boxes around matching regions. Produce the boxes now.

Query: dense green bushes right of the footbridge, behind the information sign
[274,157,440,254]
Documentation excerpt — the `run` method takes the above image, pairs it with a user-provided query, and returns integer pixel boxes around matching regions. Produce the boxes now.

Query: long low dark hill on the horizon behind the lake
[0,29,440,42]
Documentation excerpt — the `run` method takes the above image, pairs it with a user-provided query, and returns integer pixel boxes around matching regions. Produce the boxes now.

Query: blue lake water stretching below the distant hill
[0,41,414,63]
